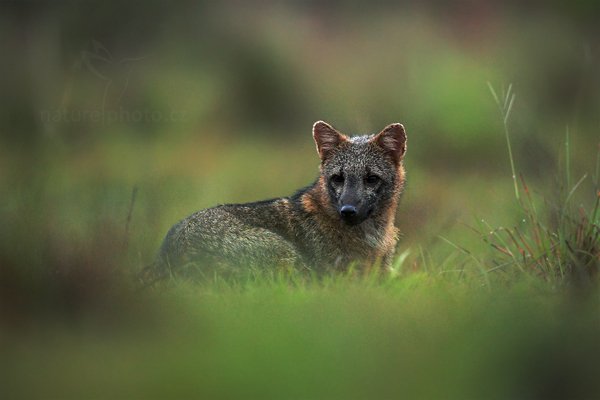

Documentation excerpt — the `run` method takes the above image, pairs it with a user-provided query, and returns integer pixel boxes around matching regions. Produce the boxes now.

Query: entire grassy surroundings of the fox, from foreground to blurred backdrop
[0,1,600,399]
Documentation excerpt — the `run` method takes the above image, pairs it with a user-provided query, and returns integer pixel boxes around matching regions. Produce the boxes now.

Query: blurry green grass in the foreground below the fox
[1,273,600,399]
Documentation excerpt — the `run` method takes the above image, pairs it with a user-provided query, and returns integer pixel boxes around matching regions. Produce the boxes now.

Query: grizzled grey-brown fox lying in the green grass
[146,121,407,278]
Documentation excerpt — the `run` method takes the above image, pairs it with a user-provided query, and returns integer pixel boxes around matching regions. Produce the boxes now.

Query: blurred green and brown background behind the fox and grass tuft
[0,0,600,396]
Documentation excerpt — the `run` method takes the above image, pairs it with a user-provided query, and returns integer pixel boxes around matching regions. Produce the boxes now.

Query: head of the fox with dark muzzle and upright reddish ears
[313,121,406,225]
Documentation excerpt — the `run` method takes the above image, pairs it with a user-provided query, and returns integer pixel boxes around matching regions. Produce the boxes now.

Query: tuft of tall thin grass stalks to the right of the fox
[468,84,600,290]
